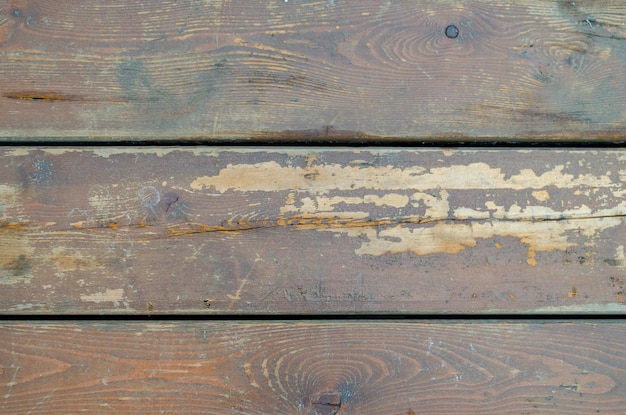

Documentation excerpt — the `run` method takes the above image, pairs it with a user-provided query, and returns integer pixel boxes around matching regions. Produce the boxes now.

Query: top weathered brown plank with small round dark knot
[0,0,626,141]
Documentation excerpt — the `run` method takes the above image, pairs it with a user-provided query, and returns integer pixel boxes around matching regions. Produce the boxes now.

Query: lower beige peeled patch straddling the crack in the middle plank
[281,191,626,266]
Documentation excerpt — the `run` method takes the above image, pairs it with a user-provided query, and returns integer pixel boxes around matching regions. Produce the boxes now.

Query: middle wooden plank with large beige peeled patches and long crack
[0,147,626,314]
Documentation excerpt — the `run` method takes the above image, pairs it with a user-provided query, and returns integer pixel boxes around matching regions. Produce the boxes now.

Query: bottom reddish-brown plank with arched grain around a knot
[0,321,626,415]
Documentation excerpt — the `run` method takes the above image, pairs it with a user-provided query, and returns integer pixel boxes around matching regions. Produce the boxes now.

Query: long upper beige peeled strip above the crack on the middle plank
[190,161,615,194]
